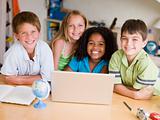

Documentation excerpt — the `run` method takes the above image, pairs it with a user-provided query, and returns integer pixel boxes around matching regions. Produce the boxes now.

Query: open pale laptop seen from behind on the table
[51,71,114,104]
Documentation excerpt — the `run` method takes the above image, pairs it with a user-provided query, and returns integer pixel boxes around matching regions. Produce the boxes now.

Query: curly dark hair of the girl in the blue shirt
[75,27,118,61]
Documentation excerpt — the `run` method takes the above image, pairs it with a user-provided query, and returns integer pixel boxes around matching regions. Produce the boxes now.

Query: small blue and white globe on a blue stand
[32,80,50,109]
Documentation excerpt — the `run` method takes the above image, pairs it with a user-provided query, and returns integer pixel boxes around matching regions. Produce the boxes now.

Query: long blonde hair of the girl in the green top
[51,10,88,47]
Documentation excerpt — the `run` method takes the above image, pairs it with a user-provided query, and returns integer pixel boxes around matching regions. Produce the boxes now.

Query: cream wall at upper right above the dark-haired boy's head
[63,0,160,27]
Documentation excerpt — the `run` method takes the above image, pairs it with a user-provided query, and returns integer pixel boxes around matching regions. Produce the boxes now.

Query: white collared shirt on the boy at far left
[1,40,54,81]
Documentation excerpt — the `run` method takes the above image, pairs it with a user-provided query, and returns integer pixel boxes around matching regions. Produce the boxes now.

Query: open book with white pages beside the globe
[0,85,36,105]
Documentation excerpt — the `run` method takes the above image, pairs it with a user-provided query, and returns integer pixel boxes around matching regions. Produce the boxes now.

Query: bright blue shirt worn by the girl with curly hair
[69,57,108,73]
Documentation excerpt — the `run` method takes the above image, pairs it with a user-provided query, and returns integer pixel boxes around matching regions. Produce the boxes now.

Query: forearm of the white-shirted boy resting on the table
[4,75,42,85]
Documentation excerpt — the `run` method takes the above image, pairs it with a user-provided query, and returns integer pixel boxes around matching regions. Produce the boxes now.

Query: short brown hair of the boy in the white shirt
[12,11,41,33]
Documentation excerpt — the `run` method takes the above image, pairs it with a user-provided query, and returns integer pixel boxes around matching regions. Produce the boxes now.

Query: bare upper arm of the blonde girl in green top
[52,39,65,70]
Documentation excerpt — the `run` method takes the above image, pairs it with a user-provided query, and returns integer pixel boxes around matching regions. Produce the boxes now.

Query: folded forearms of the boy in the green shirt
[114,84,153,100]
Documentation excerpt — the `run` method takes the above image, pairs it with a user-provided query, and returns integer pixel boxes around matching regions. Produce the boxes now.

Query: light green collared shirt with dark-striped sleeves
[109,50,160,95]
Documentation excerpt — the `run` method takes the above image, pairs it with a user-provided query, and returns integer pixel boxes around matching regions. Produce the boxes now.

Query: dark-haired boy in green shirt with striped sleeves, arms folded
[109,19,160,99]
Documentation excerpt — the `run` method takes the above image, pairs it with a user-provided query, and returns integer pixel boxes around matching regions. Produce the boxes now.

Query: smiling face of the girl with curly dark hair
[87,33,106,62]
